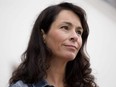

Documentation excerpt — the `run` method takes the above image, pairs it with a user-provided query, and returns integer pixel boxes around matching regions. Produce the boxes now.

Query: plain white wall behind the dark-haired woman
[0,0,116,87]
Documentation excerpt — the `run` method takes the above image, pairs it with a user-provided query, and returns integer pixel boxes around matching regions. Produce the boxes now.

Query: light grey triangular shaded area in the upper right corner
[87,0,116,23]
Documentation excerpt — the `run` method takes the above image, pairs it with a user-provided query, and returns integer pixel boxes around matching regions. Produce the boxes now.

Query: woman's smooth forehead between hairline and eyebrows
[54,10,81,26]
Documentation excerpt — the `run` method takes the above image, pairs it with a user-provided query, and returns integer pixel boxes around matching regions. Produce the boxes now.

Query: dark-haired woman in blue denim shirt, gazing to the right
[10,2,97,87]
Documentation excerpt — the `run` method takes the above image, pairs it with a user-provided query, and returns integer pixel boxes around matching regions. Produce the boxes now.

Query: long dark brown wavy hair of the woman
[9,2,97,87]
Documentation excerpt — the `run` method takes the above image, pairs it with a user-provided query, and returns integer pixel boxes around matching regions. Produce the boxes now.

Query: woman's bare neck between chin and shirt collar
[47,58,66,87]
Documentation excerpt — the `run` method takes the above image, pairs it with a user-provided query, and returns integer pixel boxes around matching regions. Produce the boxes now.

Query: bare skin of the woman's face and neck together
[43,10,83,87]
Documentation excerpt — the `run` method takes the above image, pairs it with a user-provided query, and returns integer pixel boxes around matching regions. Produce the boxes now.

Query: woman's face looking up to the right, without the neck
[43,10,83,61]
